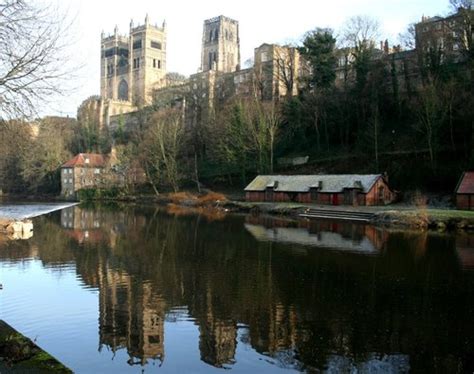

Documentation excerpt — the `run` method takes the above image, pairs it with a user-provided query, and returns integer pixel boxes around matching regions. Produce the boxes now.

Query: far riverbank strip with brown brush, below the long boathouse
[0,191,474,231]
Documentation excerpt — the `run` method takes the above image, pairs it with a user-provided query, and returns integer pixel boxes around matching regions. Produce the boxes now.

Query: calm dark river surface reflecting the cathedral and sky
[0,207,474,373]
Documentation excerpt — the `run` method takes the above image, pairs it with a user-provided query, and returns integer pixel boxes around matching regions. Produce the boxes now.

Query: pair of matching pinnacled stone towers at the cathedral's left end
[100,15,166,109]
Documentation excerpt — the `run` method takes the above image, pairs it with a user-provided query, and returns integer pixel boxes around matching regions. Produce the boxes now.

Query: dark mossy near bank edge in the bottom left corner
[0,320,72,374]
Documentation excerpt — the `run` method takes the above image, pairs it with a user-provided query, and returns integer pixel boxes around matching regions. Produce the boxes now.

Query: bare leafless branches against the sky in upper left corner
[0,0,72,119]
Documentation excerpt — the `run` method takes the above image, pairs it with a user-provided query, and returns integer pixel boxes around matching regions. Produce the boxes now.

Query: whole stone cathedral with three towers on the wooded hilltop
[82,16,301,129]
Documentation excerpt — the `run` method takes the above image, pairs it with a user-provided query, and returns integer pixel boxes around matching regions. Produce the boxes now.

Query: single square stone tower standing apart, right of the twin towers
[201,16,240,73]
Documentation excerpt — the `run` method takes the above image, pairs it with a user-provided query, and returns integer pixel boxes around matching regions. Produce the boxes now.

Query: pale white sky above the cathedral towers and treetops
[46,0,449,116]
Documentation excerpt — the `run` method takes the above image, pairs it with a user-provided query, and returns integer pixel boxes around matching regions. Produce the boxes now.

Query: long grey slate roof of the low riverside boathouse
[245,174,382,193]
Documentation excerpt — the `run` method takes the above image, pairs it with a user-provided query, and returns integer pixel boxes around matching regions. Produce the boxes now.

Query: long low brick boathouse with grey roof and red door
[245,174,395,206]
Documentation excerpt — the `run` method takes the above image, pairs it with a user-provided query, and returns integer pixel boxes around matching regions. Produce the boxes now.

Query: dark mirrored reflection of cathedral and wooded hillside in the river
[2,207,474,372]
